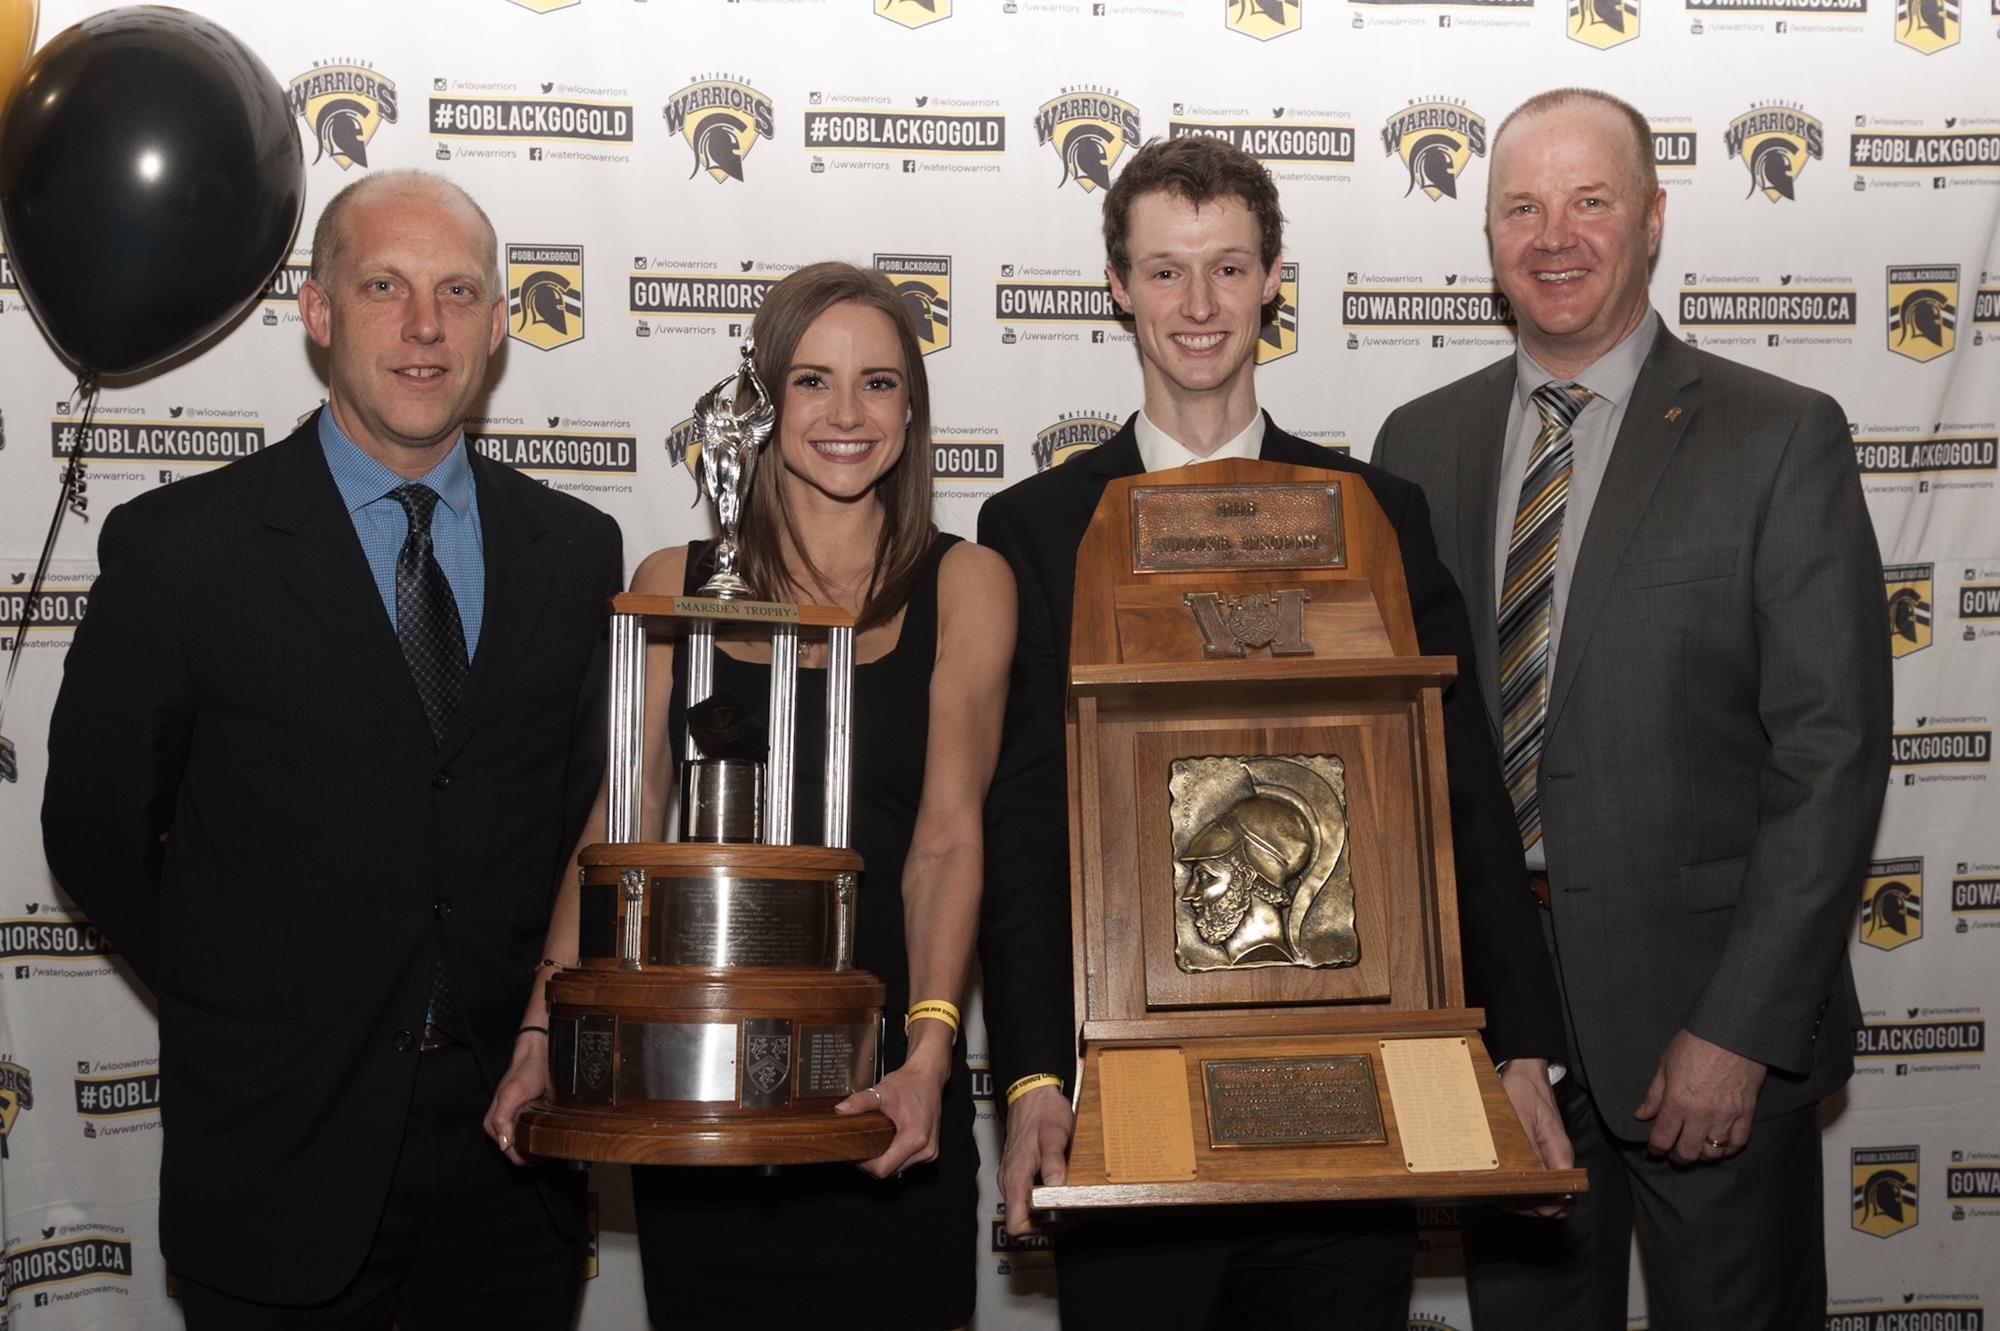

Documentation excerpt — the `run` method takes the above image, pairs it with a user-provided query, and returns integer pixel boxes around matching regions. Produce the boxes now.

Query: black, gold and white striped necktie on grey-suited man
[1500,384,1592,845]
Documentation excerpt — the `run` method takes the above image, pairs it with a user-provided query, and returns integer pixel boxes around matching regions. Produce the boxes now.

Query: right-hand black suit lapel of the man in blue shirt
[438,454,548,759]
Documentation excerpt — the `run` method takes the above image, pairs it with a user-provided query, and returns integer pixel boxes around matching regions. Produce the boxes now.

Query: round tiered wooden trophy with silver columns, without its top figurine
[520,594,896,1165]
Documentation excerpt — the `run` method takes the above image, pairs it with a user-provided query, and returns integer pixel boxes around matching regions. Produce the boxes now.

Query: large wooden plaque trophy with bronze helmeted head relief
[1032,462,1584,1209]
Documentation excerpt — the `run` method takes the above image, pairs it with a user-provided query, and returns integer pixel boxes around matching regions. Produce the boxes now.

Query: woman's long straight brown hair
[740,264,938,630]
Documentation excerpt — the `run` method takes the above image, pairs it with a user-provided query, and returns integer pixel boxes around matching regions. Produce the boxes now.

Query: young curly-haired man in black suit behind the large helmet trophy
[980,138,1570,1331]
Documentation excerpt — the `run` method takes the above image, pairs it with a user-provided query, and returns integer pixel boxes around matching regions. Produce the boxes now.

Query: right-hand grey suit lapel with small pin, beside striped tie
[1544,324,1702,733]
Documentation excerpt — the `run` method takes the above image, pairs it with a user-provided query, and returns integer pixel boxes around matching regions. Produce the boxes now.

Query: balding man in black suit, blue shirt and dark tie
[42,172,622,1331]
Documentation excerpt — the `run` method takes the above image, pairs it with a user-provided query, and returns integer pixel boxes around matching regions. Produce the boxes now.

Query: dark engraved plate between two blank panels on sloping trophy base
[1202,1053,1388,1147]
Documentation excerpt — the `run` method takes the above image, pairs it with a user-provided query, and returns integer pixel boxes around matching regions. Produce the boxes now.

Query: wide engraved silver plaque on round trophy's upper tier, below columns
[646,877,840,967]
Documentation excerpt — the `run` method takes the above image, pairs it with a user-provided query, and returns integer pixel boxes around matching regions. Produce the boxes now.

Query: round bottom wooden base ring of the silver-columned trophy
[520,1101,896,1165]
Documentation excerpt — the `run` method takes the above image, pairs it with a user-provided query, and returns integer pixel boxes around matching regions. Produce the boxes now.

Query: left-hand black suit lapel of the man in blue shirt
[264,416,432,745]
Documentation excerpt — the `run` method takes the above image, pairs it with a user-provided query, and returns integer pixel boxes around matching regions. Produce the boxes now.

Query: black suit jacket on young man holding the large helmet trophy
[980,416,1562,1091]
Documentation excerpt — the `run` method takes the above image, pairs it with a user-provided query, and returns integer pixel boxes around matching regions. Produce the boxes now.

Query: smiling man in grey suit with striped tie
[1374,90,1890,1331]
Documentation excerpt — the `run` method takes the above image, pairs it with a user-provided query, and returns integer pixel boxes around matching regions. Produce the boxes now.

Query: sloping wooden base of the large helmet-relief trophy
[1032,1013,1586,1211]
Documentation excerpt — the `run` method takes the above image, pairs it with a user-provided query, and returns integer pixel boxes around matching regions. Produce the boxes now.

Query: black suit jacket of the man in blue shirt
[42,418,620,1303]
